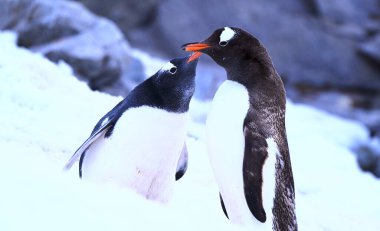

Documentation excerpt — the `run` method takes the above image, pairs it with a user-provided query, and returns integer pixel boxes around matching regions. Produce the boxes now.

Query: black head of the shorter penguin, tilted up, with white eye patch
[151,57,198,112]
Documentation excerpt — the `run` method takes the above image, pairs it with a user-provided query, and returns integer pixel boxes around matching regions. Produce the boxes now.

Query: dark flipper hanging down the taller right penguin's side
[243,125,268,222]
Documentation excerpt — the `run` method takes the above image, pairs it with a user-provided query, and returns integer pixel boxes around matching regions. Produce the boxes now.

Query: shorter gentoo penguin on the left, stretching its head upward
[64,57,197,202]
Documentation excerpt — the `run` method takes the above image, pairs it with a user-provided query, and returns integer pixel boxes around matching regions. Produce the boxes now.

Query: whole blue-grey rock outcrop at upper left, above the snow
[0,0,145,96]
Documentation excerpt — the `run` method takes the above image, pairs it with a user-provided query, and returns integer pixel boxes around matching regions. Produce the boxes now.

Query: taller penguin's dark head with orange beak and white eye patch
[182,27,266,69]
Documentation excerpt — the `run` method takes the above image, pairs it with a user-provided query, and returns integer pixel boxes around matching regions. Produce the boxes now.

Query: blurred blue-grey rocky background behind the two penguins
[0,0,380,177]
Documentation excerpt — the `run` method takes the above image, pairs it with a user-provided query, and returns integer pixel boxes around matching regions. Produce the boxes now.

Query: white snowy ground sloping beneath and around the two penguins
[0,33,380,231]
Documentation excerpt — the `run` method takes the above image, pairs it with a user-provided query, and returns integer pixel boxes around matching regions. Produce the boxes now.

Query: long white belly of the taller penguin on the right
[206,80,271,227]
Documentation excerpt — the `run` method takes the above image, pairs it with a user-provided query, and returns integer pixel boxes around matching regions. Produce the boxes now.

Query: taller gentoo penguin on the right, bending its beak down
[183,27,297,231]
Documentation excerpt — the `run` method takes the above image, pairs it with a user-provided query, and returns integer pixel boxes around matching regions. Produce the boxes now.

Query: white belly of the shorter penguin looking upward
[82,106,188,202]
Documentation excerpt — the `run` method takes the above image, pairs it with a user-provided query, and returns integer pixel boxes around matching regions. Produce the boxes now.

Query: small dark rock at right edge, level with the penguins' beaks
[358,34,380,66]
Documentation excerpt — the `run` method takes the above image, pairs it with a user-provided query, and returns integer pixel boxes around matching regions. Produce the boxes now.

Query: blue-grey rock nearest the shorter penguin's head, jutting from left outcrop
[31,19,143,95]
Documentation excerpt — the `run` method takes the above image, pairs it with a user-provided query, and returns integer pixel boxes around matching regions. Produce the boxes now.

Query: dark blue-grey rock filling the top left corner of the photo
[0,0,97,47]
